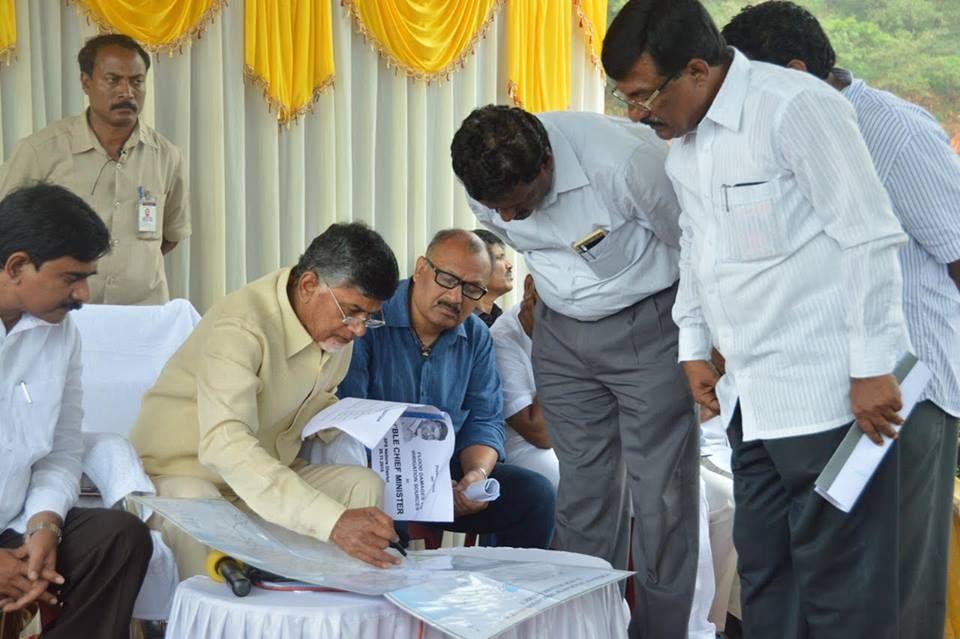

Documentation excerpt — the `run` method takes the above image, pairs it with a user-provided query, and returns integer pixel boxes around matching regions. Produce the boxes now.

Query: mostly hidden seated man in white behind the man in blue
[492,276,560,490]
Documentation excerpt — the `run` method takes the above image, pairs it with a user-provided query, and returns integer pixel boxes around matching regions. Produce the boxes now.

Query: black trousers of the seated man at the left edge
[0,508,153,639]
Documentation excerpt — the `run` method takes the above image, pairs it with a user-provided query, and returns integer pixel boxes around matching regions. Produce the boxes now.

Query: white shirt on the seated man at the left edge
[0,315,83,532]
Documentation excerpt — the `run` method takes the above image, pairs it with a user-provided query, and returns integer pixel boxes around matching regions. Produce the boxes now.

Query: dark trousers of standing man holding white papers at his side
[727,407,900,639]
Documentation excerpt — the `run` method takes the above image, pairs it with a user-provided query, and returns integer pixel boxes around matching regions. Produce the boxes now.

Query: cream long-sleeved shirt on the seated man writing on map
[130,268,351,541]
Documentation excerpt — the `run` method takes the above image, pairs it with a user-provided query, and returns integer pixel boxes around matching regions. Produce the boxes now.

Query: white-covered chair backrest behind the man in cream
[71,299,200,437]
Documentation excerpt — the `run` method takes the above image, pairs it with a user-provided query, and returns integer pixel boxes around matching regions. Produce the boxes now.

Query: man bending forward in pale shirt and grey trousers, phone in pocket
[451,105,699,639]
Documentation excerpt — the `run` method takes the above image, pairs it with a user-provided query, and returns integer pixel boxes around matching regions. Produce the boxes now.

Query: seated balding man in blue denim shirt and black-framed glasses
[339,229,554,548]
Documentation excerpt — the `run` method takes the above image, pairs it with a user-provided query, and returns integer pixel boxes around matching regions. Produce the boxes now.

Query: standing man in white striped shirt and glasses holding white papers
[603,0,910,639]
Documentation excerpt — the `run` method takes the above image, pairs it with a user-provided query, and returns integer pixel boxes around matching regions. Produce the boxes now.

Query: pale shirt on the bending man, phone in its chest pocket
[468,111,680,321]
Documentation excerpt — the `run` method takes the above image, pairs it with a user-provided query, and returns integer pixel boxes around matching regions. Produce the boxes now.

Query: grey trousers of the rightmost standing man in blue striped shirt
[898,401,958,639]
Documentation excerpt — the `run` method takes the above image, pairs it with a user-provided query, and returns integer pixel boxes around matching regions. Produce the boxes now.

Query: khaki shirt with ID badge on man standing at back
[0,113,190,304]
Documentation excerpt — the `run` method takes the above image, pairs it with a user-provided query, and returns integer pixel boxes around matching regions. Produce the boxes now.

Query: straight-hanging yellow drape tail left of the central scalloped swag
[243,0,335,124]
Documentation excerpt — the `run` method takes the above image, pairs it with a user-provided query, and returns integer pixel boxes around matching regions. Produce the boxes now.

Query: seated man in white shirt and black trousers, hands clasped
[0,184,153,639]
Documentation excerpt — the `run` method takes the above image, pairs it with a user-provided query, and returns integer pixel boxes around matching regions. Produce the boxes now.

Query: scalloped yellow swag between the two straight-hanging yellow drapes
[342,0,502,80]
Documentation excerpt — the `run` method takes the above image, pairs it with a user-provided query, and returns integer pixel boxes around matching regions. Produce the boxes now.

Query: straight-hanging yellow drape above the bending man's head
[507,0,573,113]
